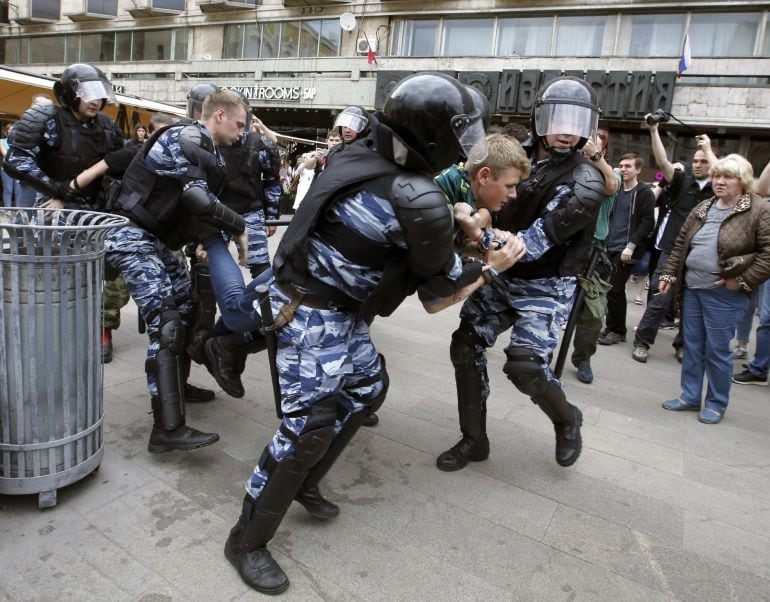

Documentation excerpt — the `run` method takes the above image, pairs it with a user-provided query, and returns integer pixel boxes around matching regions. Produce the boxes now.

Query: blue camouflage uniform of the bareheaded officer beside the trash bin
[105,124,223,397]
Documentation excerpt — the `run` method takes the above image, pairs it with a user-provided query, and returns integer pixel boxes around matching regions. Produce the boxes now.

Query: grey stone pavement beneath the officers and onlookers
[0,278,770,601]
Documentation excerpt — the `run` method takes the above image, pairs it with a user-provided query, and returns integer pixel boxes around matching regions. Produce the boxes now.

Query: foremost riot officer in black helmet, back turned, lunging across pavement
[222,73,510,594]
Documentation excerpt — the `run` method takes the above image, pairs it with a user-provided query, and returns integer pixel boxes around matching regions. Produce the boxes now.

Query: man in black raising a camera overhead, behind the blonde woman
[631,111,716,363]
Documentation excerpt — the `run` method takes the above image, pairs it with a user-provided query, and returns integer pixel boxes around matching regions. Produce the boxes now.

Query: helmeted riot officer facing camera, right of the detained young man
[436,77,604,471]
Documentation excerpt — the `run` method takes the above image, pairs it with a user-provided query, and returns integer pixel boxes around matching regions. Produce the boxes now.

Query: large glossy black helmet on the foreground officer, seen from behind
[379,72,486,173]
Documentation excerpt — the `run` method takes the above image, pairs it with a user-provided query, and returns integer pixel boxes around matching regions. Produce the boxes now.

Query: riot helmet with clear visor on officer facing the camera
[530,76,601,154]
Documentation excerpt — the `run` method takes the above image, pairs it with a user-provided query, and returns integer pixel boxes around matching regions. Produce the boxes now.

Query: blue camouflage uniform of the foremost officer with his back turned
[246,191,462,498]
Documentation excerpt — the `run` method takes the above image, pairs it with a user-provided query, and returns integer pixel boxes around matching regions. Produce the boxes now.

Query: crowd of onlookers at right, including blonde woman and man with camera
[572,117,770,424]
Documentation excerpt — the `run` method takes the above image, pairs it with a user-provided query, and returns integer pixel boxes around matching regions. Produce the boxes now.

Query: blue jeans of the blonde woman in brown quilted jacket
[680,286,749,412]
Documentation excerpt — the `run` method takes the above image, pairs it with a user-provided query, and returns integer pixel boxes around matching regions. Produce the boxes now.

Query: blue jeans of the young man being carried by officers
[203,238,273,334]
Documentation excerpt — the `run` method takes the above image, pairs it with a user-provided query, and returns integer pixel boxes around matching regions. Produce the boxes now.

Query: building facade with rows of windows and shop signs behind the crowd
[0,0,770,169]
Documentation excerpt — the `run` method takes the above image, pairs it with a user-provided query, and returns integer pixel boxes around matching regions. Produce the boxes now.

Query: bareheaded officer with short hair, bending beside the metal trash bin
[105,91,247,453]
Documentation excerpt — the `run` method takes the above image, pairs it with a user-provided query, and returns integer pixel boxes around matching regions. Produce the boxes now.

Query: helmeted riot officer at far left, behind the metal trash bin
[3,63,123,210]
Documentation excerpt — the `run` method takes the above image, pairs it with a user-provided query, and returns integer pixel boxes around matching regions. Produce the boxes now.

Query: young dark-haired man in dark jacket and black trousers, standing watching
[598,153,655,345]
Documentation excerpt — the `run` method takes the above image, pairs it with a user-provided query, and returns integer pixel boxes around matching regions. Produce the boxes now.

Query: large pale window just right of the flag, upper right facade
[689,13,759,56]
